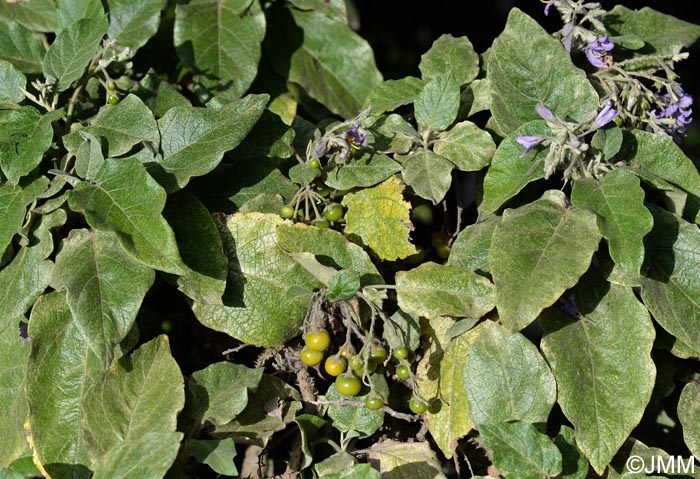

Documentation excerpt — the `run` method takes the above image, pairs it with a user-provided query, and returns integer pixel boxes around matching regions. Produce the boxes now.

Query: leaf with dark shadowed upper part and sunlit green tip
[163,193,228,304]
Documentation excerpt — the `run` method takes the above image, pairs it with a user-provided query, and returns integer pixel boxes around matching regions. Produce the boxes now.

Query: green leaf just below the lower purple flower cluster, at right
[571,169,654,276]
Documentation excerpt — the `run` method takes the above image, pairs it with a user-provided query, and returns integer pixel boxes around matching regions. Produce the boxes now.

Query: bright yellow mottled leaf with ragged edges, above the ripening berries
[342,176,417,261]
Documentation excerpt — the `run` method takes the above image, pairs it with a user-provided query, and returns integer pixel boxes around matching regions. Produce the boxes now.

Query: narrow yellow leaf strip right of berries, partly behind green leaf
[428,321,482,459]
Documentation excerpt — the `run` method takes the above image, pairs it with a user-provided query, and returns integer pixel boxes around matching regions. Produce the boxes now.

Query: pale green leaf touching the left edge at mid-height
[0,202,58,320]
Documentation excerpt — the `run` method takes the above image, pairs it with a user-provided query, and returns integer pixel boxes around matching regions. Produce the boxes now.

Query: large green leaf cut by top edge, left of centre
[174,0,266,99]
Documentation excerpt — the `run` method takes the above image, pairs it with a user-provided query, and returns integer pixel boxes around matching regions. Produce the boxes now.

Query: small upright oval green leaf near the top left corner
[43,18,107,91]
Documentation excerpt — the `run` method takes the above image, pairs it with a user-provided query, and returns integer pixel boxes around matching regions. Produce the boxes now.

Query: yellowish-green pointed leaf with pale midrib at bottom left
[81,335,185,464]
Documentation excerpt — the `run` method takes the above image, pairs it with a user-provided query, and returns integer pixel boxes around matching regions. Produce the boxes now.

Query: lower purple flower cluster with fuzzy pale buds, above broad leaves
[515,100,619,181]
